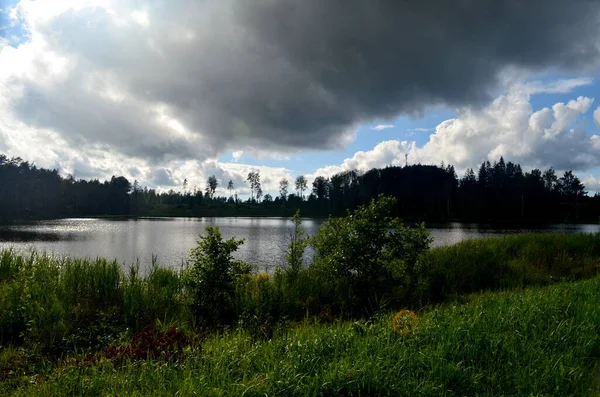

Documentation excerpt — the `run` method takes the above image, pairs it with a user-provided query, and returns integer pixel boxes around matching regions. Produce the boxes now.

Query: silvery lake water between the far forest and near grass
[0,218,599,270]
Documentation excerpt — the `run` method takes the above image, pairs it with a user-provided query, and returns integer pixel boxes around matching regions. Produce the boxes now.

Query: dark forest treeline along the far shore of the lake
[0,155,600,222]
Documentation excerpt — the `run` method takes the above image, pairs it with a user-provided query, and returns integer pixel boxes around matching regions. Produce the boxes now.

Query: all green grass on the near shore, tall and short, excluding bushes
[0,234,600,395]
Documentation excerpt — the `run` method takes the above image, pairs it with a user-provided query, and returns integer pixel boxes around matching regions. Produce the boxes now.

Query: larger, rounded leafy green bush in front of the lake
[312,195,431,311]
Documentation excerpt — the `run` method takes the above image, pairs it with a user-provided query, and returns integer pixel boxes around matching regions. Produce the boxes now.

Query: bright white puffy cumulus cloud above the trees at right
[314,82,600,180]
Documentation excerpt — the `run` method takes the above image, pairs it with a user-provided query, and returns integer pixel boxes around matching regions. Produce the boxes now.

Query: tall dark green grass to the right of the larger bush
[425,233,600,299]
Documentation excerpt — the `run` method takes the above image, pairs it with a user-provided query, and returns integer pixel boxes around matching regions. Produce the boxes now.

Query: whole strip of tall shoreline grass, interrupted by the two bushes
[0,230,600,354]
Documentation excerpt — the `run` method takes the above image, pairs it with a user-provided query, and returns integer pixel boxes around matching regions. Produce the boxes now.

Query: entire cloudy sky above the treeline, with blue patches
[0,0,600,194]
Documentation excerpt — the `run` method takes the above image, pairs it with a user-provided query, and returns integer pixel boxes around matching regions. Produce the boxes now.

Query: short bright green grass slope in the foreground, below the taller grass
[2,278,600,396]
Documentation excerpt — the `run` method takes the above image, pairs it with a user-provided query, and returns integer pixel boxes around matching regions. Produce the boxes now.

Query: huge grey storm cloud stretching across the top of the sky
[7,0,600,160]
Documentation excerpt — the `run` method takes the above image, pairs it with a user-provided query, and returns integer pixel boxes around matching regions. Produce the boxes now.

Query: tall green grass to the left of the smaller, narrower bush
[0,250,189,351]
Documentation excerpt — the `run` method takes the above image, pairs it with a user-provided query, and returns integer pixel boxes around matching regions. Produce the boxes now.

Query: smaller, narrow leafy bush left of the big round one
[185,226,251,327]
